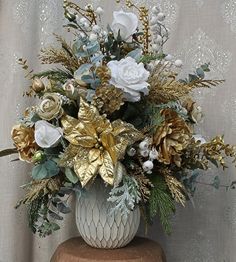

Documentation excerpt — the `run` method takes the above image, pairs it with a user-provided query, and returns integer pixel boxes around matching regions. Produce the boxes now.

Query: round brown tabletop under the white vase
[51,237,166,262]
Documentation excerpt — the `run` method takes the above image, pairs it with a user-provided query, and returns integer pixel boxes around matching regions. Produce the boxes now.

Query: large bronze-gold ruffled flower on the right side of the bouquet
[153,109,191,167]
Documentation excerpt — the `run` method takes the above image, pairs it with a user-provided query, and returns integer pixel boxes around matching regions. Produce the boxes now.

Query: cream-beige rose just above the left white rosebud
[37,93,63,121]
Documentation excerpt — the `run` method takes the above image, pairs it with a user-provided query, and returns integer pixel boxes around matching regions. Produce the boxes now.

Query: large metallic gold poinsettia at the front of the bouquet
[61,98,143,187]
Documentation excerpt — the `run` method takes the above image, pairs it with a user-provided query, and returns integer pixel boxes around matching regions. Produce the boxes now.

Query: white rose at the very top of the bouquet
[111,10,138,40]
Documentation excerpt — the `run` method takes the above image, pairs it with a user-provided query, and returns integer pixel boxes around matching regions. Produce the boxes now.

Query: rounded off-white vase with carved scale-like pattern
[76,180,140,249]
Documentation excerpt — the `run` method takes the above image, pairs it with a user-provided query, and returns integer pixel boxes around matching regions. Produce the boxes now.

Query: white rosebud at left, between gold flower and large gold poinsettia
[34,120,63,148]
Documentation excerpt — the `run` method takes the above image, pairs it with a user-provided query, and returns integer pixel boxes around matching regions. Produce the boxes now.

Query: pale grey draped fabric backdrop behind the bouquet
[0,0,236,262]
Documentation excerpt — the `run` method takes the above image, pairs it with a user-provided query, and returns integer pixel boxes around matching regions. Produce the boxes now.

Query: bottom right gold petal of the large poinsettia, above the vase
[99,151,114,185]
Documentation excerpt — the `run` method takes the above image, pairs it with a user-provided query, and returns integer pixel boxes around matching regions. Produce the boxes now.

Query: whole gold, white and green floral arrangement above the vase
[0,0,236,236]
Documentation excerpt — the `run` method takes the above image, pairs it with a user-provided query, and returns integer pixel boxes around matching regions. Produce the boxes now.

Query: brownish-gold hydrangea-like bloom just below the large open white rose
[92,85,124,115]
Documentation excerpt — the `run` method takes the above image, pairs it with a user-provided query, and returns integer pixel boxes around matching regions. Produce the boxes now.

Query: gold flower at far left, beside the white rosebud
[11,124,38,162]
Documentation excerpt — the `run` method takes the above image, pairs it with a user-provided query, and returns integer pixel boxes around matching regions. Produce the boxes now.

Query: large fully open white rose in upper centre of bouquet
[107,57,150,102]
